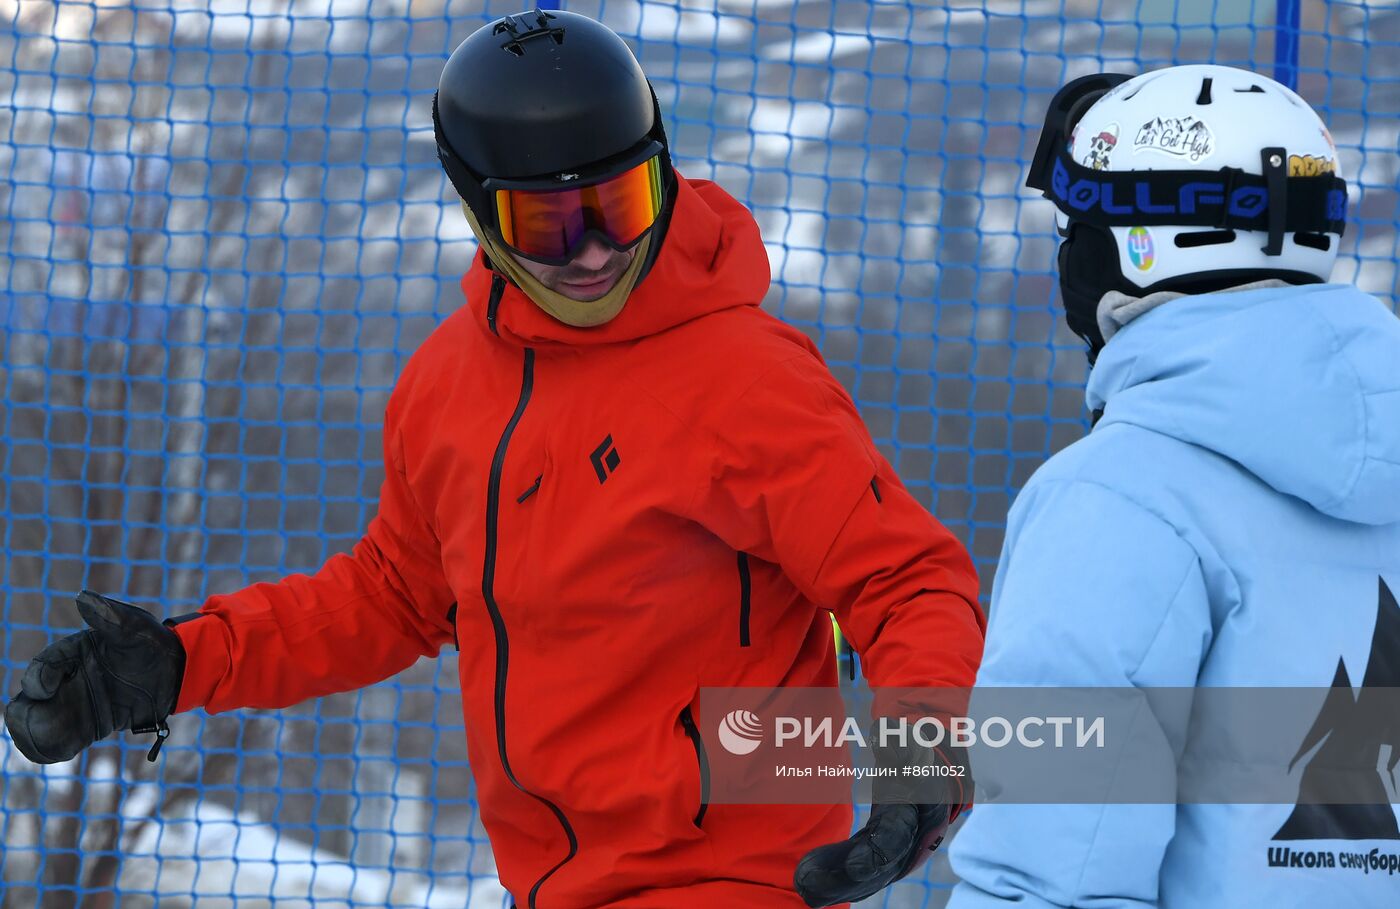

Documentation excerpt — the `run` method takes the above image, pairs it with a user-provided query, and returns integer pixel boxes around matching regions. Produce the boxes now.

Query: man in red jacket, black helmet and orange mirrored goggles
[6,11,984,909]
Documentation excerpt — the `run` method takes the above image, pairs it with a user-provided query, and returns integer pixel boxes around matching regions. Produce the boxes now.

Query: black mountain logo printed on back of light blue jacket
[1274,580,1400,840]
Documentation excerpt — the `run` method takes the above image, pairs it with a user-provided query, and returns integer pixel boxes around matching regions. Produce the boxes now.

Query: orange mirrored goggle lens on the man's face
[496,155,662,259]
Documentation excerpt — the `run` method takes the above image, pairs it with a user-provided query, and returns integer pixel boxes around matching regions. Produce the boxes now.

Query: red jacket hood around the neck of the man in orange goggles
[462,175,771,347]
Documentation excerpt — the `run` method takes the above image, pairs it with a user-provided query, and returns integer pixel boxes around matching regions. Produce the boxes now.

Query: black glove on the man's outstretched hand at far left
[4,590,185,763]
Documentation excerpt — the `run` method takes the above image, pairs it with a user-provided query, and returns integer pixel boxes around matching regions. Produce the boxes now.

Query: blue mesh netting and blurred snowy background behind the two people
[0,0,1400,909]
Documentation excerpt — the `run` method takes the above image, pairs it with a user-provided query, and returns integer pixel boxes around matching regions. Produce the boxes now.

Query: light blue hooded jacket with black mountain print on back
[949,284,1400,909]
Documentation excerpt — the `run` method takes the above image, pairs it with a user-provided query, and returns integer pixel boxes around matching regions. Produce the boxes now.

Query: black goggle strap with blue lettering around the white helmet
[1026,147,1347,255]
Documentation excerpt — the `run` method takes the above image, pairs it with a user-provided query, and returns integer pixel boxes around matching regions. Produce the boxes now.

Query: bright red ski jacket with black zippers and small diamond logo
[176,181,984,909]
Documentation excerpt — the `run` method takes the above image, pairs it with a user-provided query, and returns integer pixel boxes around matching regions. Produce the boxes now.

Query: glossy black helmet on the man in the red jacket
[433,8,676,275]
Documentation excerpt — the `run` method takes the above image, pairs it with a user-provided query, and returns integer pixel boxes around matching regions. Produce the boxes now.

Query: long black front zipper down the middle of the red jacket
[482,345,578,909]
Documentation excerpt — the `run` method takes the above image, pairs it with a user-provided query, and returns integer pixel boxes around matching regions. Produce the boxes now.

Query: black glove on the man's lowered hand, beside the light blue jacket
[792,745,972,908]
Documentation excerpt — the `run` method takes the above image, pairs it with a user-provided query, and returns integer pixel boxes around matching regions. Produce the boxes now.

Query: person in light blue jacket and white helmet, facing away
[949,66,1400,909]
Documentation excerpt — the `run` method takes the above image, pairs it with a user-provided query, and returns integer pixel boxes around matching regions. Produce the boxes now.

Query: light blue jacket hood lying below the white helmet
[1088,284,1400,524]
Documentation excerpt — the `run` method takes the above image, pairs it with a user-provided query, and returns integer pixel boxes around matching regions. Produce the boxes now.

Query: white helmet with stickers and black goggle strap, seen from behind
[1026,66,1347,359]
